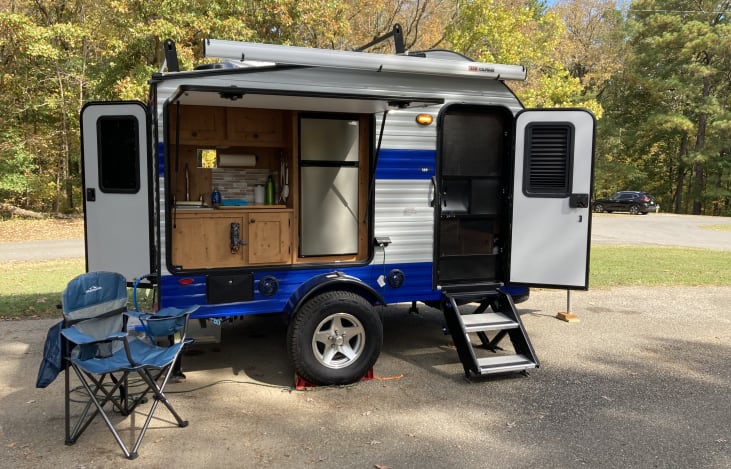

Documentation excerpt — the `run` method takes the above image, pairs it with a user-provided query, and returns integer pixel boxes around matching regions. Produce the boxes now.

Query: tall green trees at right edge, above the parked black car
[603,0,731,215]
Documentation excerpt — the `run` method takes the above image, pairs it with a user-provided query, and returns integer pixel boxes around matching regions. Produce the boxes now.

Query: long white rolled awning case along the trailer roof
[203,39,526,80]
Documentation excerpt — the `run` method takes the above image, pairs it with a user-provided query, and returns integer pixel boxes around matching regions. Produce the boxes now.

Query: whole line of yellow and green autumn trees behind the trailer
[0,0,731,215]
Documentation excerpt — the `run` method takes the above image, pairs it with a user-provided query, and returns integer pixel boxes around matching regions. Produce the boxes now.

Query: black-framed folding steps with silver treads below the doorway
[442,289,540,378]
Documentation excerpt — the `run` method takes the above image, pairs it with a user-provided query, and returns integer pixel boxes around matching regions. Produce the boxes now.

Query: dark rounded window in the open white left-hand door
[96,116,140,194]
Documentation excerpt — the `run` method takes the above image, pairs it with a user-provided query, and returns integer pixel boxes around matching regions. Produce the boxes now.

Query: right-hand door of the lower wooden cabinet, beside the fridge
[248,212,292,264]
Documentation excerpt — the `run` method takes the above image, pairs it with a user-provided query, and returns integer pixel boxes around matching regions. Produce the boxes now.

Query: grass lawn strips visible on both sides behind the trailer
[0,245,731,319]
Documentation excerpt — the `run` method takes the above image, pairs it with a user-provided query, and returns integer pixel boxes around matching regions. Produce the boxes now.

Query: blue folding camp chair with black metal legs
[61,272,197,459]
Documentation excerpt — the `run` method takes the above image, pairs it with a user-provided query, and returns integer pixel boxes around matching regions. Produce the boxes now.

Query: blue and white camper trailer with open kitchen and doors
[81,33,595,384]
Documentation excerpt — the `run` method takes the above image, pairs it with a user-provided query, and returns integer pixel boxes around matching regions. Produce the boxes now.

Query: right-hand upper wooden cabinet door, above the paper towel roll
[226,108,284,147]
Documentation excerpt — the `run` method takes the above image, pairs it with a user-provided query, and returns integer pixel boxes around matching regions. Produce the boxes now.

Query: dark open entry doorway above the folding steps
[434,104,513,287]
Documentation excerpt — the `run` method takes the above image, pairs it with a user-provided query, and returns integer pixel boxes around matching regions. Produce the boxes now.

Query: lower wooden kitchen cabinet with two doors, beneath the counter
[171,208,292,270]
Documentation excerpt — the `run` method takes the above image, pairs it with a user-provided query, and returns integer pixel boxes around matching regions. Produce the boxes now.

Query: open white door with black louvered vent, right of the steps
[510,110,594,289]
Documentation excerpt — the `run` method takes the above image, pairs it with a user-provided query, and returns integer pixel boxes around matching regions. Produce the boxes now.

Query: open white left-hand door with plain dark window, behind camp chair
[81,102,154,281]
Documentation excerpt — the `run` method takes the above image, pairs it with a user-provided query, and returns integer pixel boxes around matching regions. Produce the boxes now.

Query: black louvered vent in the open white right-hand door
[523,122,574,197]
